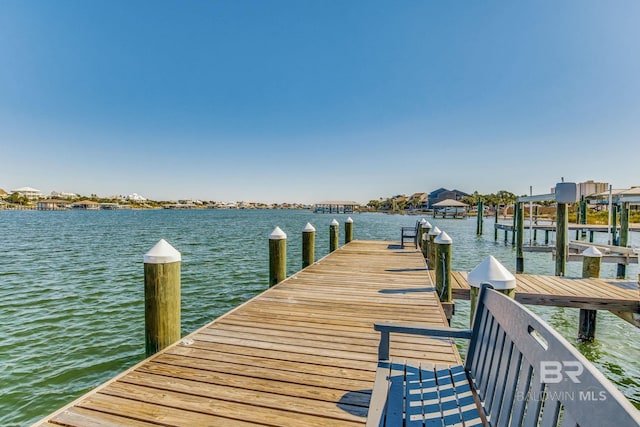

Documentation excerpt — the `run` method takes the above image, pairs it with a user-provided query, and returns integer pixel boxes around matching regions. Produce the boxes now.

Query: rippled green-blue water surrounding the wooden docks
[0,210,640,426]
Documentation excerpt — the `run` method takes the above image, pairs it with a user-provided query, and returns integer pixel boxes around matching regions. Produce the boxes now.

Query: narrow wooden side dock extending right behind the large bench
[436,271,640,327]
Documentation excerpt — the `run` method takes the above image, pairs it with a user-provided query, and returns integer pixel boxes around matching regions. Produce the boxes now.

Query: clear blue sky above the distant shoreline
[0,0,640,203]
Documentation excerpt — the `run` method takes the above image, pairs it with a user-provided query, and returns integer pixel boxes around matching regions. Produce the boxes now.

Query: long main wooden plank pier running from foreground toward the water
[36,241,460,427]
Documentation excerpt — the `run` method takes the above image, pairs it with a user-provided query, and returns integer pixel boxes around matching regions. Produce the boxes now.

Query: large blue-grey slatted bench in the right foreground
[367,286,640,427]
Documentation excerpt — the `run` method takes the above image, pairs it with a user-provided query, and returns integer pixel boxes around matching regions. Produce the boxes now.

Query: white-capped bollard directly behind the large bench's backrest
[467,255,516,327]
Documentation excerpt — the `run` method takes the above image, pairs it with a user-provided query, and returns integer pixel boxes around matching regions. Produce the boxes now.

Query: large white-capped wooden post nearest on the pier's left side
[144,239,182,357]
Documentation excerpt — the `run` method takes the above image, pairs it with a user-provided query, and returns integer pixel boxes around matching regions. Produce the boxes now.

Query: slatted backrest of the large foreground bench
[465,287,640,426]
